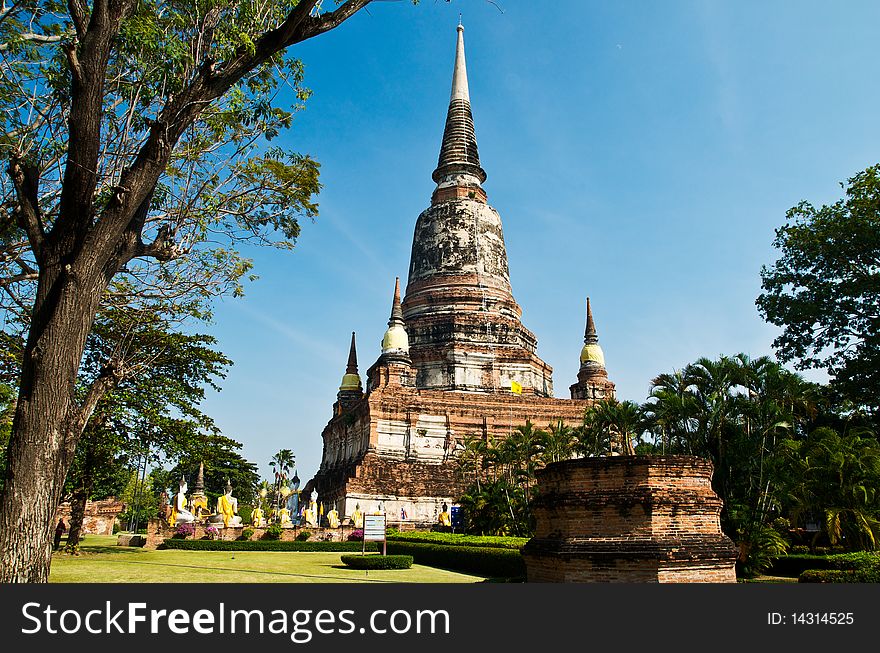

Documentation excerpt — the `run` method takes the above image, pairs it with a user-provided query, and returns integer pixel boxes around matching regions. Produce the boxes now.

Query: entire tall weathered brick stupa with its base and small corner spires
[305,25,614,523]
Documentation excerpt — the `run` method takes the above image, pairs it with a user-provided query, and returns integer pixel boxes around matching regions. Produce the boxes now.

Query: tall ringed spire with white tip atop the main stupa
[431,25,486,196]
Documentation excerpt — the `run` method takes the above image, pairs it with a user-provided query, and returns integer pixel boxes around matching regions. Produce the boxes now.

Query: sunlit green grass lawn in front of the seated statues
[49,535,484,583]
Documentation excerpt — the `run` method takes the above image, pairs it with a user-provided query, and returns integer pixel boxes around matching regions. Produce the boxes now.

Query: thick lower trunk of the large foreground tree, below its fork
[0,264,106,583]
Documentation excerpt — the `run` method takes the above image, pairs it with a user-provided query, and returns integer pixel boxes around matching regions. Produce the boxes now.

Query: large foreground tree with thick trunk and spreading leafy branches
[0,0,396,582]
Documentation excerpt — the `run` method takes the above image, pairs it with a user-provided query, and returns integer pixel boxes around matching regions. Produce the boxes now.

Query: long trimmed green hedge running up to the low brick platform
[388,538,526,578]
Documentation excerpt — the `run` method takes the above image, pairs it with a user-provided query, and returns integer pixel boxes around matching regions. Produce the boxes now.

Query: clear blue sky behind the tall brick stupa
[198,0,880,481]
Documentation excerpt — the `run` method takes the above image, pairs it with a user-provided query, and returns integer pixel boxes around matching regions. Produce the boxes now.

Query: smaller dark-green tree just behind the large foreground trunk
[65,309,231,549]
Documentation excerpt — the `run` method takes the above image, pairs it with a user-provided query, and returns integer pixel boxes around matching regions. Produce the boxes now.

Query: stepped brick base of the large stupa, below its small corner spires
[303,385,590,523]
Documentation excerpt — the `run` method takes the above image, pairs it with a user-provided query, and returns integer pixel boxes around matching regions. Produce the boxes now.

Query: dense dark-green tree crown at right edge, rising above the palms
[756,164,880,412]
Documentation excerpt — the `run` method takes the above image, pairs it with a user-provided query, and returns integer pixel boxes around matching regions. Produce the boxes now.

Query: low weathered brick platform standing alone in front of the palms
[522,456,736,583]
